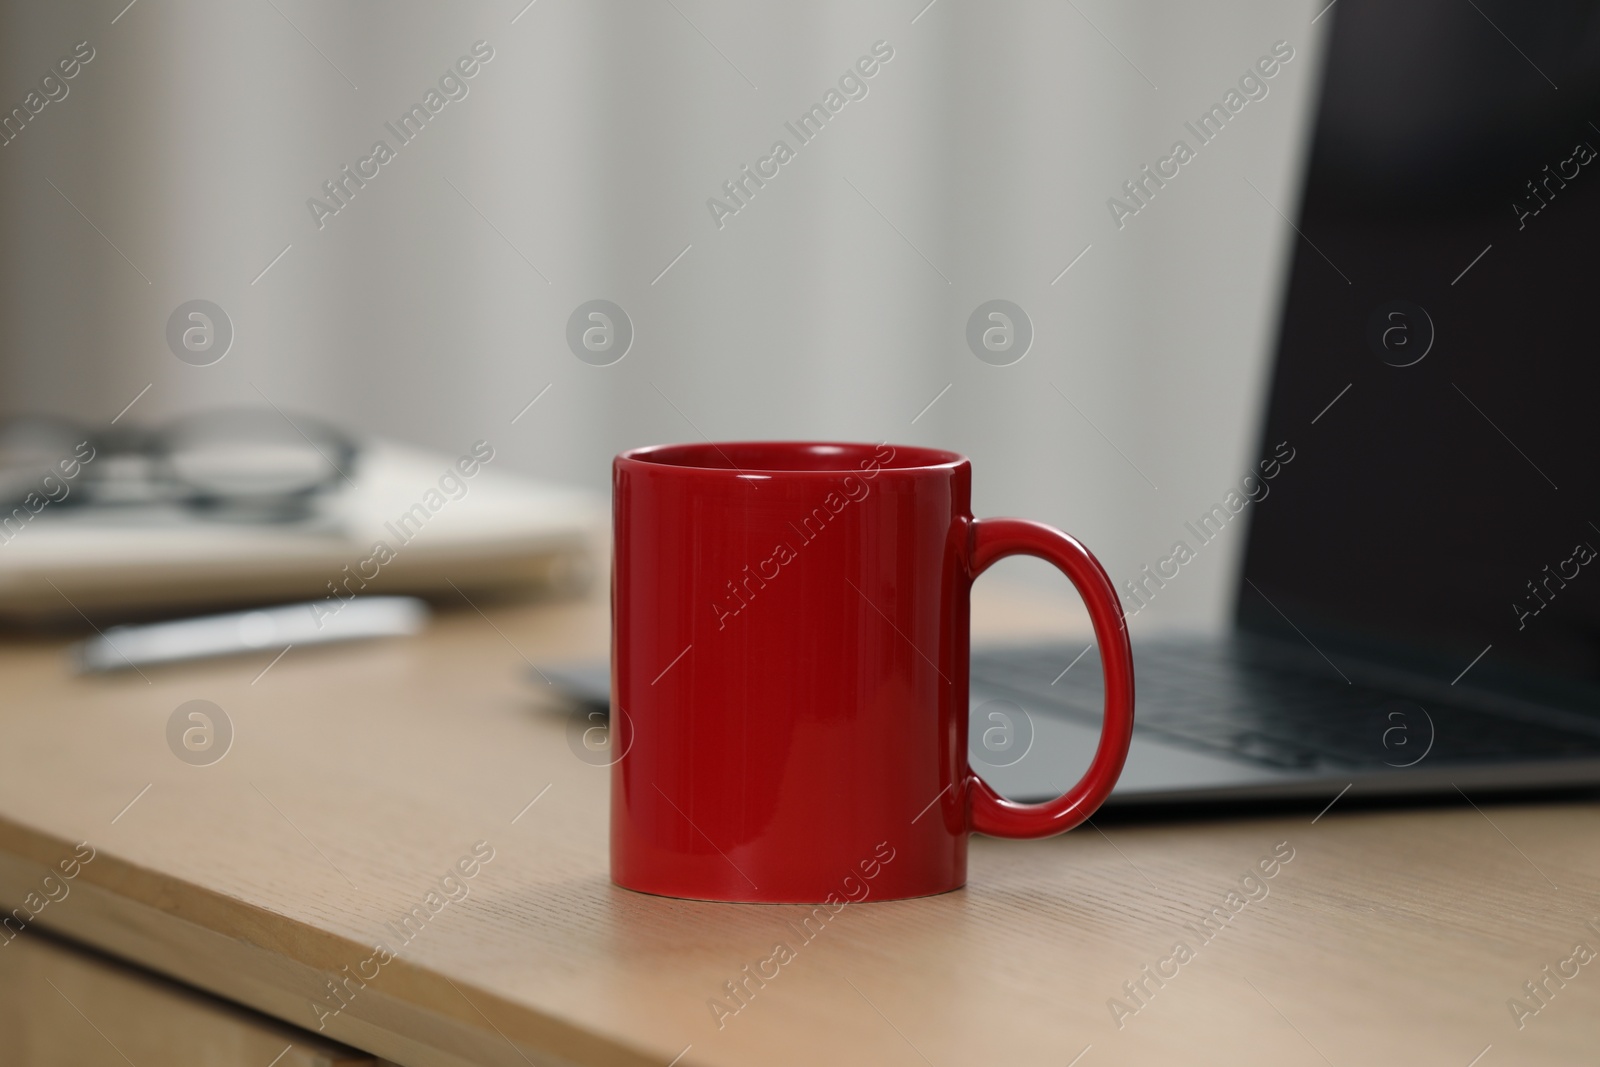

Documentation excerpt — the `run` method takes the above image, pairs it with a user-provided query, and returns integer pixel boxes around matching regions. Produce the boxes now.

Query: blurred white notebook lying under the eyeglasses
[0,442,606,625]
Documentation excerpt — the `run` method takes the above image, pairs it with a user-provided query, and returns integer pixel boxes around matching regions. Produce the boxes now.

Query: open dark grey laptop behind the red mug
[970,0,1600,806]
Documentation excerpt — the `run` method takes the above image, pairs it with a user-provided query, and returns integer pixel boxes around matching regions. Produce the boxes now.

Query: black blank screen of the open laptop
[1237,0,1600,709]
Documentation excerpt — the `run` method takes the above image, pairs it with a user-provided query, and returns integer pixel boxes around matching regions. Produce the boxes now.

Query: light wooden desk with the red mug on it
[0,582,1600,1067]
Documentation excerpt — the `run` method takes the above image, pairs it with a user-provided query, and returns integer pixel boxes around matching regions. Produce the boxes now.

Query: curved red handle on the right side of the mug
[966,518,1133,838]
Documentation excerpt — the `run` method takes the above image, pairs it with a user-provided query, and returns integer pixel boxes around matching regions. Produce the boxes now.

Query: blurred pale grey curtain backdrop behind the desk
[0,0,1331,627]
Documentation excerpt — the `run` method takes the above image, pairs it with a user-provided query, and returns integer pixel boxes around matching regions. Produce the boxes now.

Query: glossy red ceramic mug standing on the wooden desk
[611,442,1133,904]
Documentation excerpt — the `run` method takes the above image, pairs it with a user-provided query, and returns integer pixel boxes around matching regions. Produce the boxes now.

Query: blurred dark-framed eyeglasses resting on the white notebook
[0,408,358,522]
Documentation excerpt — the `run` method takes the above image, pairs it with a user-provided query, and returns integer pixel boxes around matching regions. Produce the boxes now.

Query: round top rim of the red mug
[616,440,971,477]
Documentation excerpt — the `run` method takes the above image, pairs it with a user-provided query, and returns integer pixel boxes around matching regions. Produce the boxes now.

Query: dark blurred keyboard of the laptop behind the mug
[971,640,1600,768]
